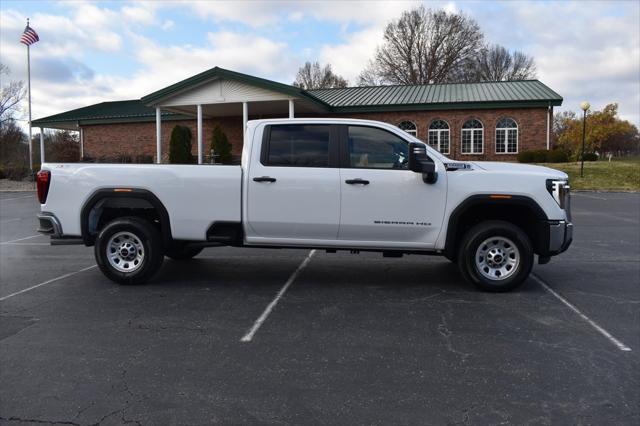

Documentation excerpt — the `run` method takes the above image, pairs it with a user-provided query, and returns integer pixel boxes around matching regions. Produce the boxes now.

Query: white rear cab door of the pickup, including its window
[246,123,340,244]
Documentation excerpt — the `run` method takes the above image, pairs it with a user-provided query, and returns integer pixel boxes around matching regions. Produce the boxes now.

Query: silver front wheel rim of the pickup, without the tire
[475,237,520,281]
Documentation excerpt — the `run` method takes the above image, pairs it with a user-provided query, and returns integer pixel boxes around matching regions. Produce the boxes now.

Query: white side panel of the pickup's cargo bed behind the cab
[42,163,242,240]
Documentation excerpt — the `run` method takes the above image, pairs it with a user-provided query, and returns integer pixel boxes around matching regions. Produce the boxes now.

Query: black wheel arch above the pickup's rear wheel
[80,188,173,246]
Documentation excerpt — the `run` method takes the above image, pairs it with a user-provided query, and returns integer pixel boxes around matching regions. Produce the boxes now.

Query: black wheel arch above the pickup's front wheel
[444,194,548,259]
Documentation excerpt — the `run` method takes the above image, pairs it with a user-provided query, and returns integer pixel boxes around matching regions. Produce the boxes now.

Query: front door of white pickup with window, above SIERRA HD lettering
[338,125,446,248]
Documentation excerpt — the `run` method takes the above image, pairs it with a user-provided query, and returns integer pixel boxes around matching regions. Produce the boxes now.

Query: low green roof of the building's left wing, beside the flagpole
[31,99,192,128]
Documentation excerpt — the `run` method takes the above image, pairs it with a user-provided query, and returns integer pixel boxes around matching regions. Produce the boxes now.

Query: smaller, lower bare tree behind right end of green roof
[458,44,536,81]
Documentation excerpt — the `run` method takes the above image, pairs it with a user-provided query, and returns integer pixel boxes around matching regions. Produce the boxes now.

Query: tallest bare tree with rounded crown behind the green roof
[360,6,483,84]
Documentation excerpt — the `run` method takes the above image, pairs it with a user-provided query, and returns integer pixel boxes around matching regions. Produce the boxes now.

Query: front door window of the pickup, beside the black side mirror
[348,126,409,170]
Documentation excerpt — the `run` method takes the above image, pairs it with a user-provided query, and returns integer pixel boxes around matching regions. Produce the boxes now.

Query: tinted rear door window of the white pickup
[263,124,331,167]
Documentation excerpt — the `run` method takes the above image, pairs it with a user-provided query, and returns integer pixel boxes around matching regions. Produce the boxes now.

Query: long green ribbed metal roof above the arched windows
[307,80,562,112]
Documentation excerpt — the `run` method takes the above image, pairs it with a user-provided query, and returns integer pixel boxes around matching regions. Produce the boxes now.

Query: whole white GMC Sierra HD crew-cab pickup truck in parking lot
[37,119,572,291]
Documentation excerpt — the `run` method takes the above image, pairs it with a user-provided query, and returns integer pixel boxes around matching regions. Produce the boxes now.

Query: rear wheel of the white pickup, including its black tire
[94,217,164,284]
